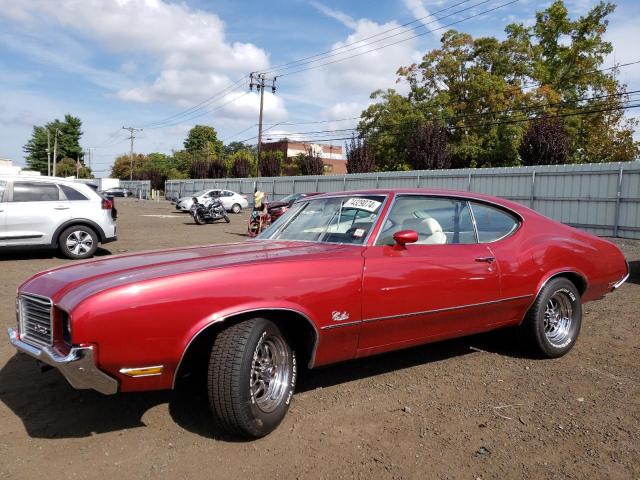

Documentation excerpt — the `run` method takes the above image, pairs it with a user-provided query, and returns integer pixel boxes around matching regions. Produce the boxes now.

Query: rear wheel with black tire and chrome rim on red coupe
[521,278,582,358]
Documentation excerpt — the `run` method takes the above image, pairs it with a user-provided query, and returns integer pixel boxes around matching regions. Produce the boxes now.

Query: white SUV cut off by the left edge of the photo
[0,175,117,259]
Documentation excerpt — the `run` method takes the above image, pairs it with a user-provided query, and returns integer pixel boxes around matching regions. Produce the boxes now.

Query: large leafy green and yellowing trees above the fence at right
[358,0,638,170]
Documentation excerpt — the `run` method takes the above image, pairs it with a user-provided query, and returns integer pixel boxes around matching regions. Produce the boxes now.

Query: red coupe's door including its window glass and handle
[358,195,500,353]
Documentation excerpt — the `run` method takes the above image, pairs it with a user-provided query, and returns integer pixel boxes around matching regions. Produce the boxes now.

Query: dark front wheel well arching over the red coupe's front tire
[173,309,318,388]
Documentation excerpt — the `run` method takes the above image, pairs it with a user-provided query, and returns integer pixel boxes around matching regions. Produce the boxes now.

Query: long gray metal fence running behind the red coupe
[165,162,640,238]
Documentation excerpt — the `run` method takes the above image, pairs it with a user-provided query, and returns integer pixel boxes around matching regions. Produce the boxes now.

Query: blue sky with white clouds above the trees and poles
[0,0,640,176]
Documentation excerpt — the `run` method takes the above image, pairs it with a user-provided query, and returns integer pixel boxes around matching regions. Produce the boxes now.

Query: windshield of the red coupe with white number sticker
[258,195,385,245]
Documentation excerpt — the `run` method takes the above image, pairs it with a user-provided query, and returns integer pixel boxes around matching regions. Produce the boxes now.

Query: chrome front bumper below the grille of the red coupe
[8,328,118,395]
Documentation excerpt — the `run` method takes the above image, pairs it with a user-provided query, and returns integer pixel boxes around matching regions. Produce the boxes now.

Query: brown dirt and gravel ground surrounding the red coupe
[0,199,640,479]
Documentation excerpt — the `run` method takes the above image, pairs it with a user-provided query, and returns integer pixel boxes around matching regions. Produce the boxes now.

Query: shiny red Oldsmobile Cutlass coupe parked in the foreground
[9,190,629,437]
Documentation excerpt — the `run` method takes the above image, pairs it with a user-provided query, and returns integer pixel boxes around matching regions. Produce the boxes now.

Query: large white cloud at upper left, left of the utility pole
[0,0,268,105]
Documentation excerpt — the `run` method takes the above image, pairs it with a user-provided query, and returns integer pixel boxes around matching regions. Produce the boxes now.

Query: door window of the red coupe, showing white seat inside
[376,195,476,245]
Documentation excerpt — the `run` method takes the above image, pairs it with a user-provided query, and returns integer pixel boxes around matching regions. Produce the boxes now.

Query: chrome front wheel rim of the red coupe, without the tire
[250,336,291,413]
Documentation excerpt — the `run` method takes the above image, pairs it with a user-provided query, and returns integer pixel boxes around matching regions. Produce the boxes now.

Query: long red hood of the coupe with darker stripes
[19,240,353,308]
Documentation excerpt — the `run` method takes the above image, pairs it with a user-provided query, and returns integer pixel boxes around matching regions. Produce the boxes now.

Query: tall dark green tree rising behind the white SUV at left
[22,114,84,175]
